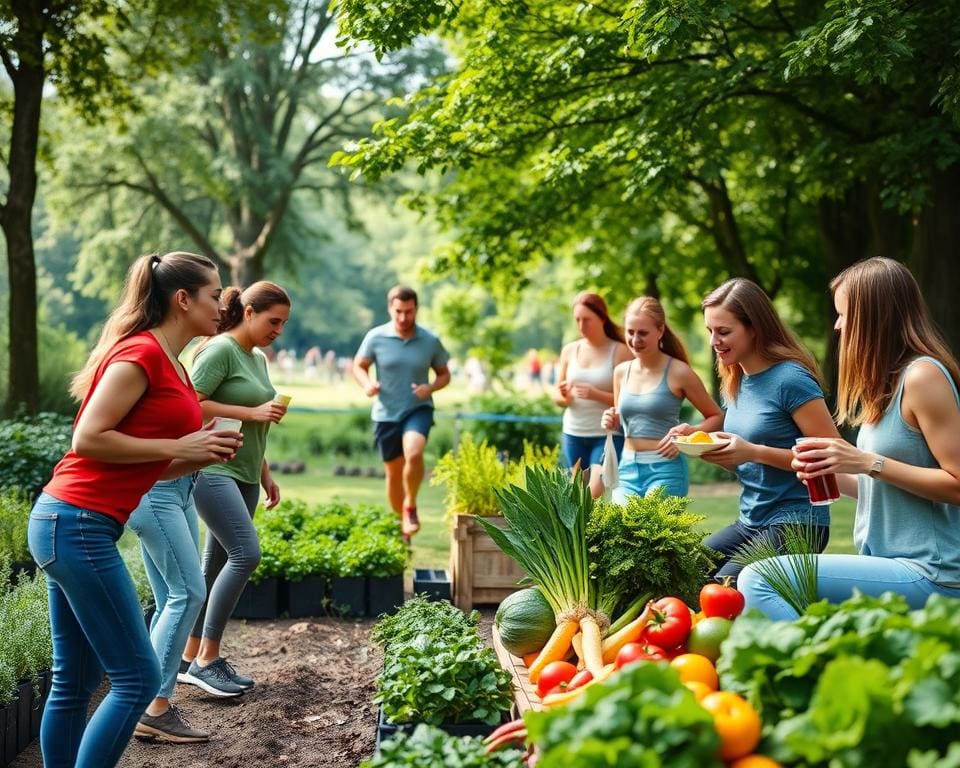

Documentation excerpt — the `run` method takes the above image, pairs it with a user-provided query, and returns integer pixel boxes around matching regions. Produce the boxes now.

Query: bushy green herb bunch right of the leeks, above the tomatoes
[587,488,713,615]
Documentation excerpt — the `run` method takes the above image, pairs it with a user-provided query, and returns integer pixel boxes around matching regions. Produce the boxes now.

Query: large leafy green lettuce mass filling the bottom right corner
[717,593,960,768]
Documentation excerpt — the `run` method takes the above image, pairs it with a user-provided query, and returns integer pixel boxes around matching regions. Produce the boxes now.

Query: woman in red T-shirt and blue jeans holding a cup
[27,252,241,768]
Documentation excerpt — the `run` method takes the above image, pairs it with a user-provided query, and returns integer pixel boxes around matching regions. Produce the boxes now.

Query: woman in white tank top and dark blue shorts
[553,291,630,499]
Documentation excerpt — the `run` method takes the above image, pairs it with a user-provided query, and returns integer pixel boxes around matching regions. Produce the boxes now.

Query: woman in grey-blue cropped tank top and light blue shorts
[602,296,723,504]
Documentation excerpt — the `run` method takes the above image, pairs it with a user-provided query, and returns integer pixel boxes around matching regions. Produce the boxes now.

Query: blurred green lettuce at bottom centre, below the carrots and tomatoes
[524,663,723,768]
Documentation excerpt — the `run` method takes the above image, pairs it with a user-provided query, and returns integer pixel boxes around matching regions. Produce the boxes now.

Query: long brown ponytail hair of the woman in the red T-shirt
[70,251,217,400]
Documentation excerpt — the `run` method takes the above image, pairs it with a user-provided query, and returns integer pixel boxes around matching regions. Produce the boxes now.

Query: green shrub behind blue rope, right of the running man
[464,390,560,456]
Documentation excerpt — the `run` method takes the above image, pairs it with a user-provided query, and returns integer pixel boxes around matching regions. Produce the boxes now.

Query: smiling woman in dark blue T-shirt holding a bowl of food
[702,278,840,579]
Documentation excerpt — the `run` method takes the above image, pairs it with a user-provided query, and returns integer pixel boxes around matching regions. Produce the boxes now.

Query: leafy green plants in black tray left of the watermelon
[371,597,513,725]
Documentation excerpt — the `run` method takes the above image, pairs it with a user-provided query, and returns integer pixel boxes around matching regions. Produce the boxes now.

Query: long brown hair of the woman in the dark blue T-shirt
[700,277,823,400]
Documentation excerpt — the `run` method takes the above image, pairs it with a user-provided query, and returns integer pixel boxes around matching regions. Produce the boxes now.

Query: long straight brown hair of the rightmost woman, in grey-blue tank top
[830,258,960,426]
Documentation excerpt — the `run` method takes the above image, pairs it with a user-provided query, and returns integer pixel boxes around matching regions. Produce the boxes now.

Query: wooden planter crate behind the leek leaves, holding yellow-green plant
[450,515,525,611]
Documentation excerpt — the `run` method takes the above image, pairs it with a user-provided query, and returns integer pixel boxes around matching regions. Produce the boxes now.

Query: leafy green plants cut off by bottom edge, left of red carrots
[360,725,523,768]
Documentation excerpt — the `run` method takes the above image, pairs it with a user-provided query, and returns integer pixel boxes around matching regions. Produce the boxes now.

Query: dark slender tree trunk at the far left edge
[0,7,45,414]
